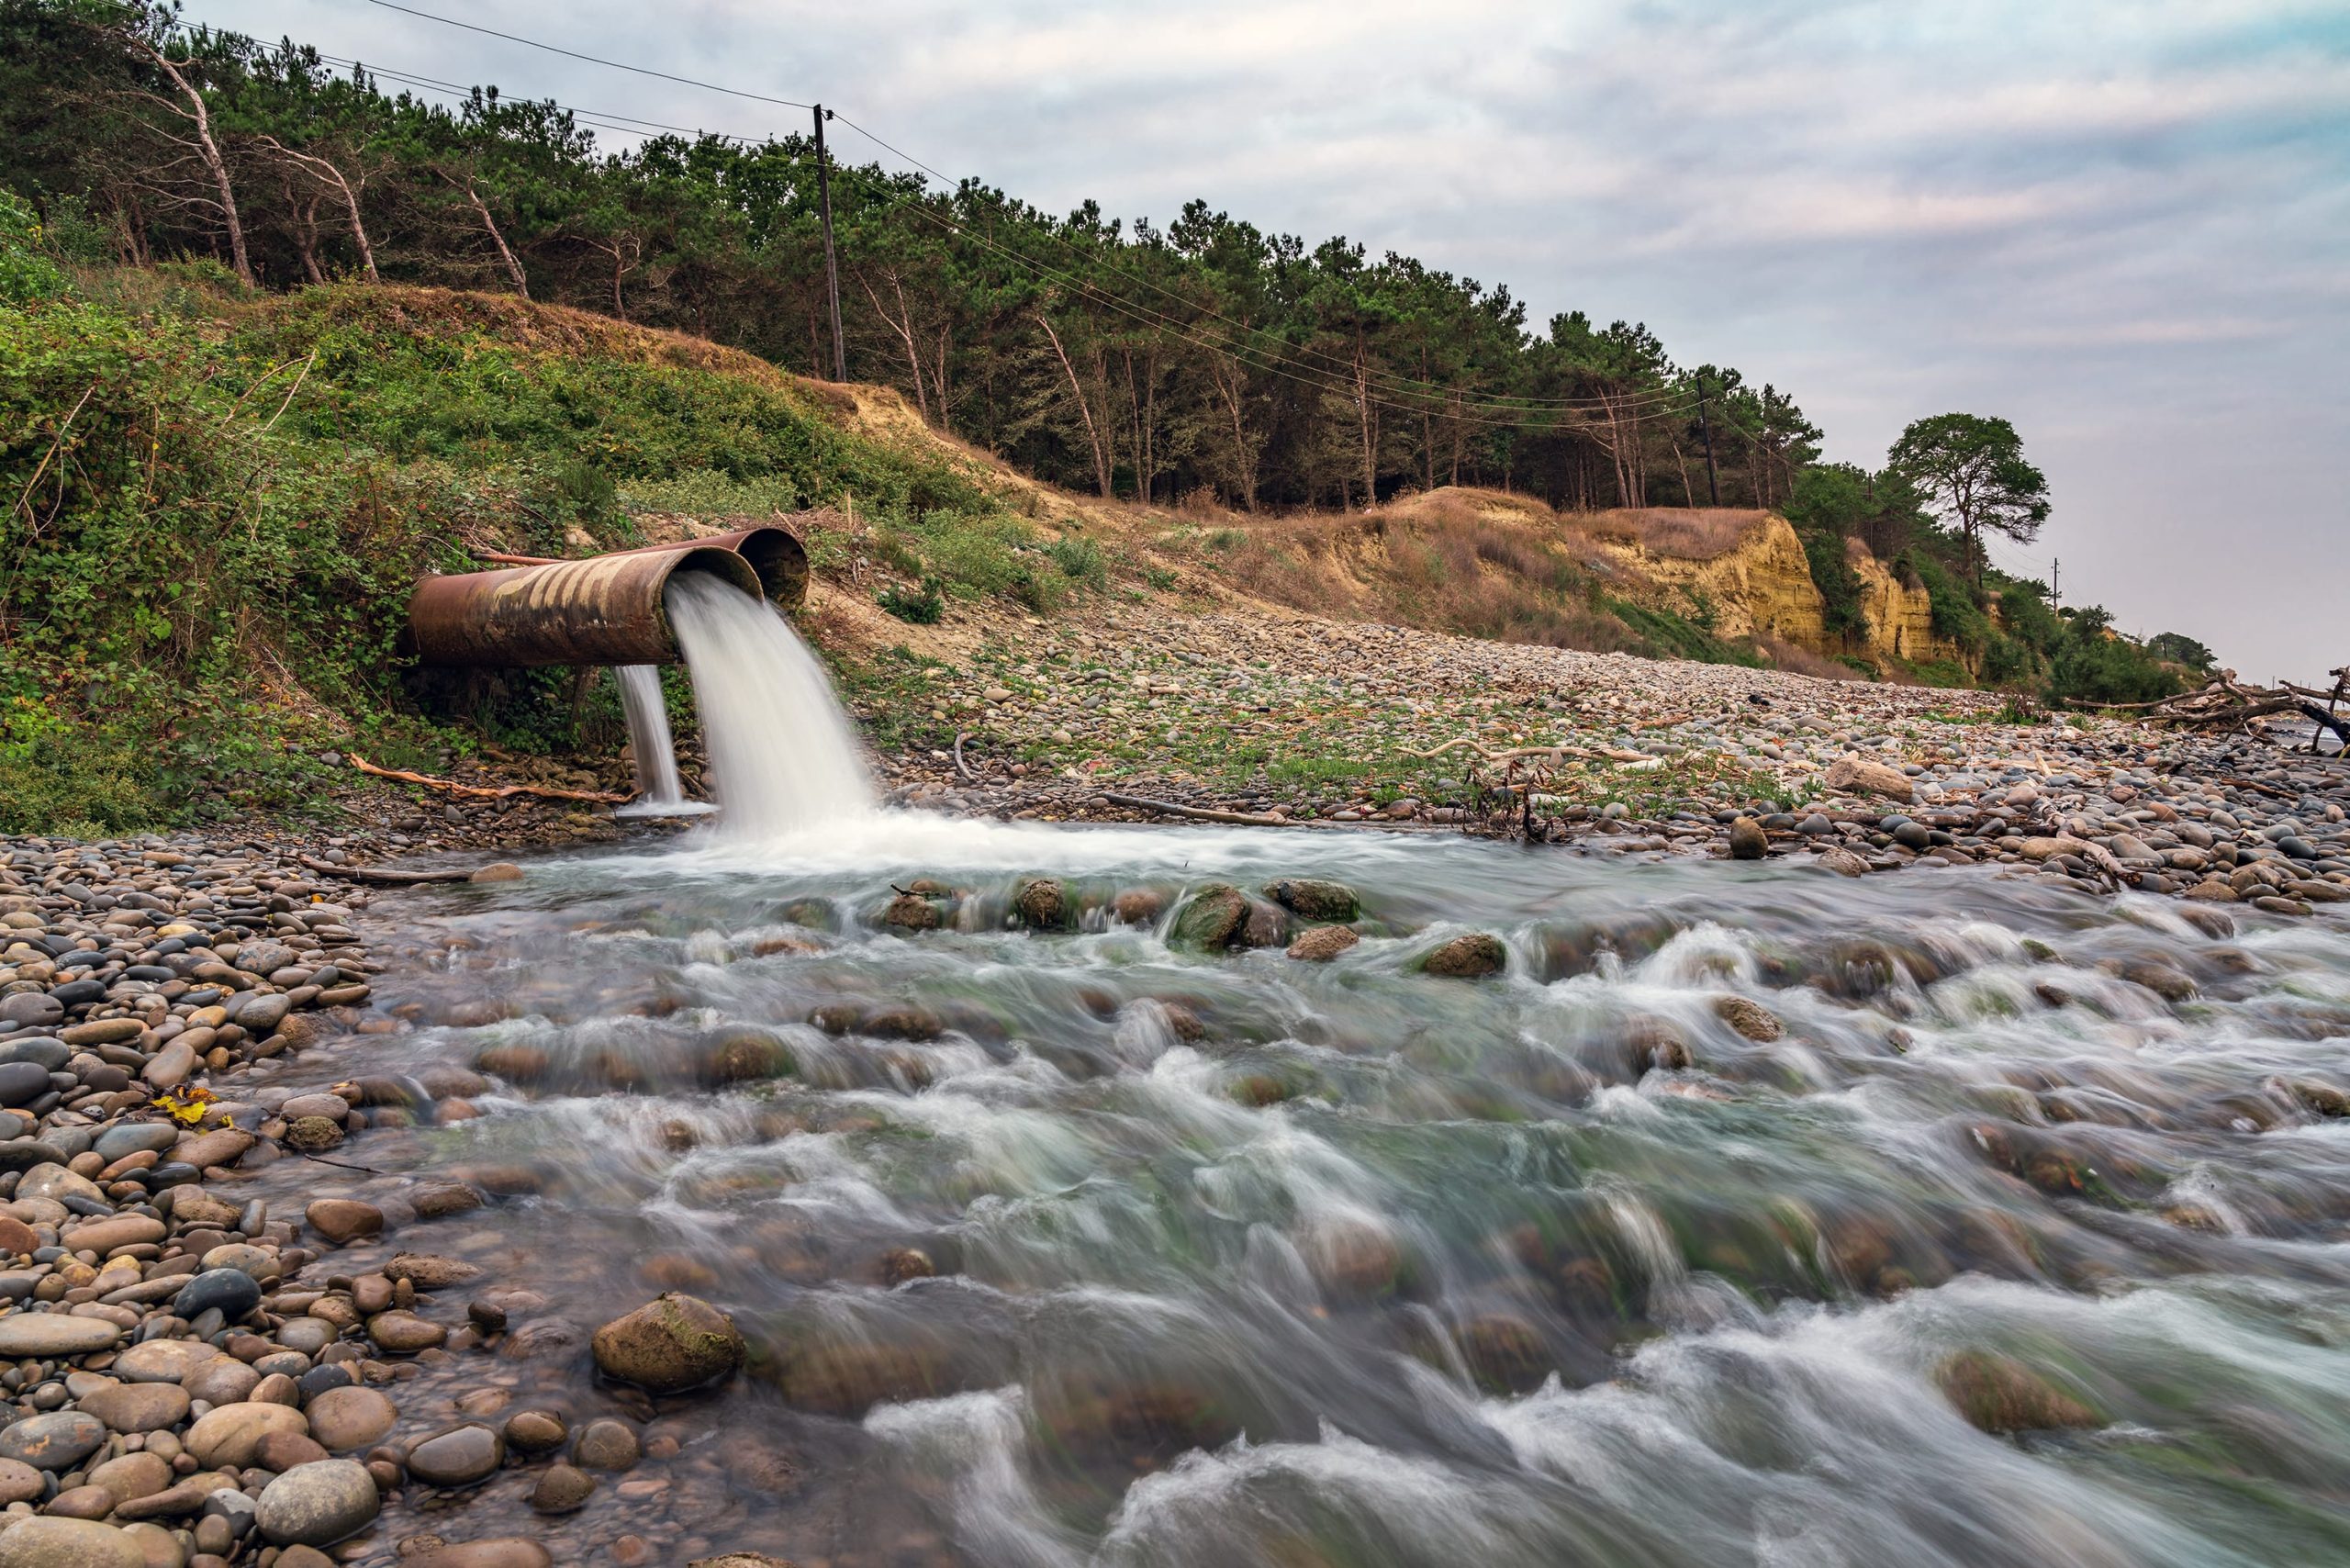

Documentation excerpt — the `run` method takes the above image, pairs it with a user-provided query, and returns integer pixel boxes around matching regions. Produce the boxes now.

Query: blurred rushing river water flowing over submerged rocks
[242,816,2350,1568]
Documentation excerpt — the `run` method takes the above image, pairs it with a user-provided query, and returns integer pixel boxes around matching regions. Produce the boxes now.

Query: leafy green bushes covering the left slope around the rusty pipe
[0,185,1029,832]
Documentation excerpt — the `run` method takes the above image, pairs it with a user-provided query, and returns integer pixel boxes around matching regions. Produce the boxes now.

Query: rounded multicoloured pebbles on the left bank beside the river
[0,834,773,1568]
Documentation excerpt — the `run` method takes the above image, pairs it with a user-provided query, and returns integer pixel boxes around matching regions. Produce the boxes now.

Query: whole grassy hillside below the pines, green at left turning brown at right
[0,206,2199,837]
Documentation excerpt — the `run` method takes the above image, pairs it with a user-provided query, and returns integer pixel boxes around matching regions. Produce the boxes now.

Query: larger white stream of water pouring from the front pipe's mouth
[665,571,877,839]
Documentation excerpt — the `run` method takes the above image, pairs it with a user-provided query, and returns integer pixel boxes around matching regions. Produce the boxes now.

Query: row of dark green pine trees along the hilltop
[0,0,2199,700]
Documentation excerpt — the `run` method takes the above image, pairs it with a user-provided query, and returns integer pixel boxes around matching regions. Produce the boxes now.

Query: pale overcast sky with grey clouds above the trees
[207,0,2350,679]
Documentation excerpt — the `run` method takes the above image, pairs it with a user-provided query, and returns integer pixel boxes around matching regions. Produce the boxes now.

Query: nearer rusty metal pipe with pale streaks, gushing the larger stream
[407,545,761,670]
